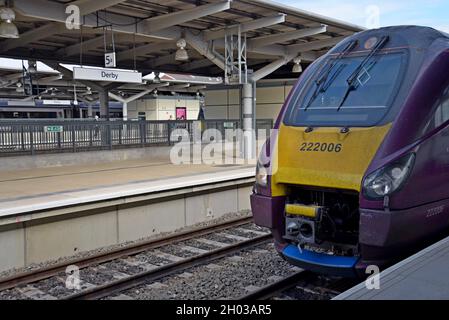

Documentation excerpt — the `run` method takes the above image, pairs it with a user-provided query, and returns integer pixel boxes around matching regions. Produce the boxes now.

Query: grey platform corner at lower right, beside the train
[334,238,449,300]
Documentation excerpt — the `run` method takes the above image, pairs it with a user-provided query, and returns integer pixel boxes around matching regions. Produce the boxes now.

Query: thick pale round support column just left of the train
[242,83,256,160]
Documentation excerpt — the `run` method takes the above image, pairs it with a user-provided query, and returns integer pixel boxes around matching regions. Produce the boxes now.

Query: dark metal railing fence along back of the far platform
[0,119,273,156]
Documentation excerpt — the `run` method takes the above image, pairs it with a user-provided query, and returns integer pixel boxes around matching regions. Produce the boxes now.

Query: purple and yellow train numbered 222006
[251,26,449,277]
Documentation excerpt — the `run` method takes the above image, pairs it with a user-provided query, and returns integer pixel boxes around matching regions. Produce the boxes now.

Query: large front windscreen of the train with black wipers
[284,52,406,127]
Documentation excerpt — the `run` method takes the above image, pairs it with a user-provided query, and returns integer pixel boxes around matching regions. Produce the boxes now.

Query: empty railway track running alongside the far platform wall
[0,218,271,299]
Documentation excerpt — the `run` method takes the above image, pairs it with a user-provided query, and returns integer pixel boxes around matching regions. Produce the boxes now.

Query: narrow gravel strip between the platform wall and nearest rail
[0,211,251,280]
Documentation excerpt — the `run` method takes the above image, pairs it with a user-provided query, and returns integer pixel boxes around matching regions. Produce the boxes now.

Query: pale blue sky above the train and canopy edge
[274,0,449,32]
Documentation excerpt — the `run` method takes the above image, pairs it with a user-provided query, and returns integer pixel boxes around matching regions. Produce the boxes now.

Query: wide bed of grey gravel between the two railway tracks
[114,244,297,300]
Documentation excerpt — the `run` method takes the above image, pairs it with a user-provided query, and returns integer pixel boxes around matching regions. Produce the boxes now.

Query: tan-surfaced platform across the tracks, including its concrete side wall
[0,158,255,272]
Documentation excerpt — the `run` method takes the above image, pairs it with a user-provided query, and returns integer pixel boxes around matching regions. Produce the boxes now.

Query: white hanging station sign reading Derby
[73,67,142,83]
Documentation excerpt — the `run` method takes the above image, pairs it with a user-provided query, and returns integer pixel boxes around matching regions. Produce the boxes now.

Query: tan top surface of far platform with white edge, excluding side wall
[0,159,254,217]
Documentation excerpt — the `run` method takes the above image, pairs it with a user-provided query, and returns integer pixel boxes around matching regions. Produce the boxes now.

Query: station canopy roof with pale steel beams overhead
[0,0,362,100]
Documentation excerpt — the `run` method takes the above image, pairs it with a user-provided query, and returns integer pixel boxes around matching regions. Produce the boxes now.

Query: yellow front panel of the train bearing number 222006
[272,124,391,196]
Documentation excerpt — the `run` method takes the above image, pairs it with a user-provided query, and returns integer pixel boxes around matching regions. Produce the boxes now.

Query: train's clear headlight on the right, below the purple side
[363,153,415,199]
